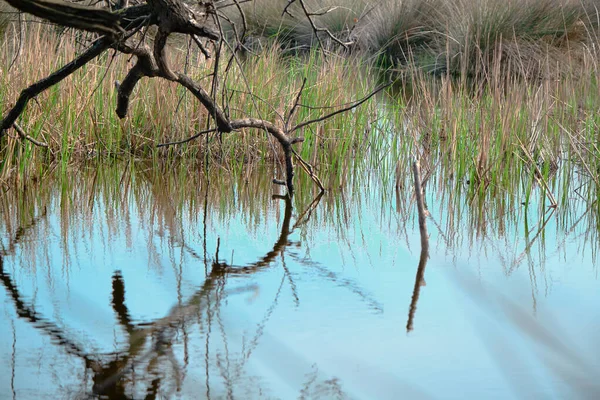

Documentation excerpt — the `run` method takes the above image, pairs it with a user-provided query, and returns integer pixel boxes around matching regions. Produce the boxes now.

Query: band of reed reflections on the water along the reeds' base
[0,162,598,300]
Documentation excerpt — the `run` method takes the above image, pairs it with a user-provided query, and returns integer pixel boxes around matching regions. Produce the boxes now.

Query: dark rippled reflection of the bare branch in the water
[0,191,338,399]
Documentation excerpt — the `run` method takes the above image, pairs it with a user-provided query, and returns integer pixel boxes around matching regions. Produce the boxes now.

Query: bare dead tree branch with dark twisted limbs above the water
[0,0,380,194]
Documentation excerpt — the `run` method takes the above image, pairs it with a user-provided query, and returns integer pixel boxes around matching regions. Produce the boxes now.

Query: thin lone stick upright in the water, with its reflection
[406,160,429,332]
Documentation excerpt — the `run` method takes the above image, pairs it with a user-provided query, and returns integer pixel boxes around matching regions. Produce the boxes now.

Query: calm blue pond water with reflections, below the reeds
[0,164,600,399]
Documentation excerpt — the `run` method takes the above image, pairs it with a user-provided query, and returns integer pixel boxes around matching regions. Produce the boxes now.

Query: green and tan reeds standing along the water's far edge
[0,0,600,241]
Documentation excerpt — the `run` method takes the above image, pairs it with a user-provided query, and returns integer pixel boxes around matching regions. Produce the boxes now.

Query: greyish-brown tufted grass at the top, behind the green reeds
[230,0,600,79]
